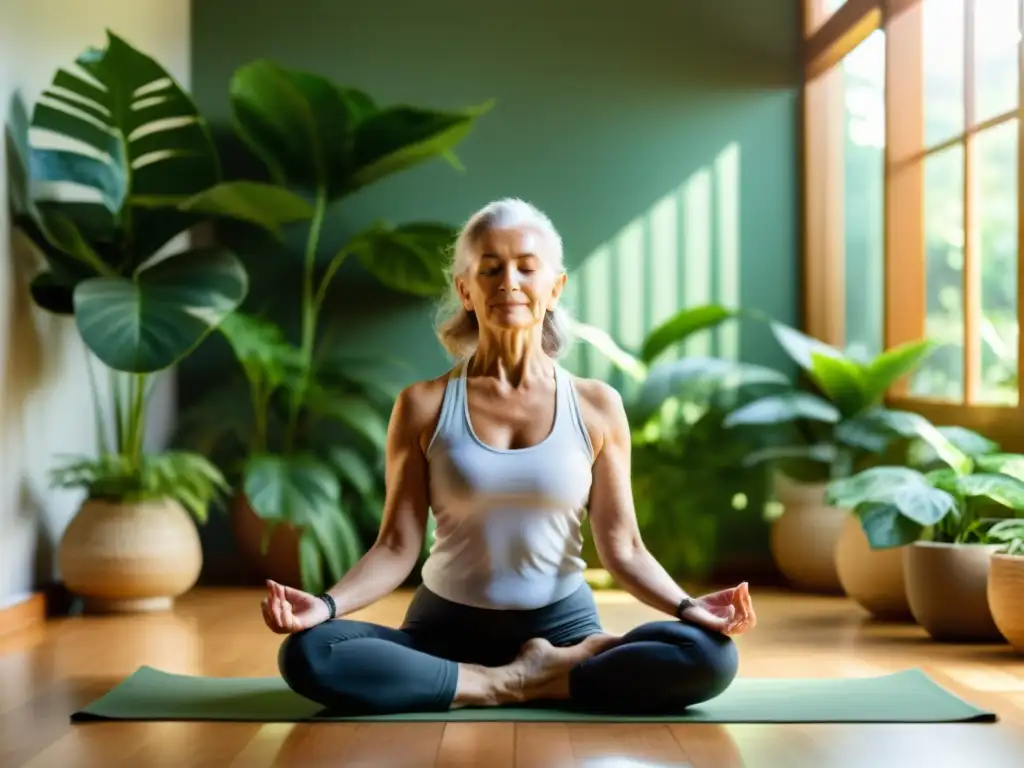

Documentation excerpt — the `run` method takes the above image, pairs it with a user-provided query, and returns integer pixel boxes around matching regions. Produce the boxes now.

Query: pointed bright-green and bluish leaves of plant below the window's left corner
[725,321,964,481]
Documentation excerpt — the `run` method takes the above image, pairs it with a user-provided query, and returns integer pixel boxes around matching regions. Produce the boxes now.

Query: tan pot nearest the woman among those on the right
[769,474,849,594]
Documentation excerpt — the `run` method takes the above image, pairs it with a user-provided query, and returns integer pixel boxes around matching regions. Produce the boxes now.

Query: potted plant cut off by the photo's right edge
[988,519,1024,653]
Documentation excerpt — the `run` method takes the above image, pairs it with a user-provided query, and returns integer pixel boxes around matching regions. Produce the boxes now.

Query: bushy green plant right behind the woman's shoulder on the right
[573,304,793,579]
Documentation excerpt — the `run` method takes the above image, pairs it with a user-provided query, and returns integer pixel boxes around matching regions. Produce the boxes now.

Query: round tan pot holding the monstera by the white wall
[57,499,203,612]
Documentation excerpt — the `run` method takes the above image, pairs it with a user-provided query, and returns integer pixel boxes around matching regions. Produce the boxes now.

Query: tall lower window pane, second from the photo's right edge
[917,144,964,401]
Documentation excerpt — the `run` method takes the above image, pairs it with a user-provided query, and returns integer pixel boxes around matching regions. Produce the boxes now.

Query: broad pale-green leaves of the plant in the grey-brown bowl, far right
[826,443,1024,549]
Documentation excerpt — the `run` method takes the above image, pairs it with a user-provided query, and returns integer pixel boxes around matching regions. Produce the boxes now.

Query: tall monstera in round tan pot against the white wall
[13,33,248,610]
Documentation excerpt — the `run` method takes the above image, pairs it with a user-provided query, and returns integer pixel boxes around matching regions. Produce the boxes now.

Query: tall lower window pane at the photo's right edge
[972,119,1018,404]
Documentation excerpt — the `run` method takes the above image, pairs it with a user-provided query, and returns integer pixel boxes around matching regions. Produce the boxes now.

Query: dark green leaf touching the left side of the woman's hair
[342,221,456,296]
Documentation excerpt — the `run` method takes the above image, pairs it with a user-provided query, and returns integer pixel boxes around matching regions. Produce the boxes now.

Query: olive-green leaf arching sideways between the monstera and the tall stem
[180,181,313,239]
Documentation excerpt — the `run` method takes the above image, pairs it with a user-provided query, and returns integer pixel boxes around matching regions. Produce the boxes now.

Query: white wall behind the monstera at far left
[0,0,190,607]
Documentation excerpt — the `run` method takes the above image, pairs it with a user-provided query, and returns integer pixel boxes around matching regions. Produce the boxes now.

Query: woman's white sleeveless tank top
[422,360,594,609]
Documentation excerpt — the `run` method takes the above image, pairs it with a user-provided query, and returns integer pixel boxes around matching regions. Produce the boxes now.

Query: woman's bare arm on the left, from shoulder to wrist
[321,382,441,616]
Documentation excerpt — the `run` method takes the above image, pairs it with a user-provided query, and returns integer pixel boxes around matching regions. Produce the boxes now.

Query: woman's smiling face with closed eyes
[457,226,565,331]
